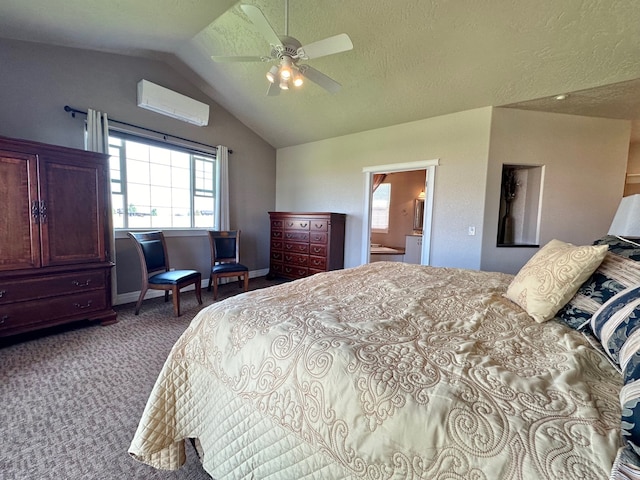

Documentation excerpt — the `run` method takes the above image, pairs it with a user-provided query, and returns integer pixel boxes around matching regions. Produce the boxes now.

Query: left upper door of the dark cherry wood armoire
[0,150,40,271]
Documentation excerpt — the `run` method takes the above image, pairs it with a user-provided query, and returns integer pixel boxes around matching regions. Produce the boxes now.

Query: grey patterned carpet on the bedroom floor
[0,278,282,480]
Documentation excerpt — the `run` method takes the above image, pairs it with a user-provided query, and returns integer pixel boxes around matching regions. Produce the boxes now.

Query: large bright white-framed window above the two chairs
[109,132,216,228]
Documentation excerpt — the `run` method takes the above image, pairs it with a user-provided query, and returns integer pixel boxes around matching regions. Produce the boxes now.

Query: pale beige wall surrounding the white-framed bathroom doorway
[276,108,492,269]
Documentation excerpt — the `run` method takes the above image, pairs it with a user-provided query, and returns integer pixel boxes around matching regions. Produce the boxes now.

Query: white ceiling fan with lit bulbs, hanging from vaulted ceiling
[211,0,353,95]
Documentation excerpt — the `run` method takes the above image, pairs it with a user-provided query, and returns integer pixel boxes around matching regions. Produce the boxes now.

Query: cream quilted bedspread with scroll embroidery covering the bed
[130,262,621,480]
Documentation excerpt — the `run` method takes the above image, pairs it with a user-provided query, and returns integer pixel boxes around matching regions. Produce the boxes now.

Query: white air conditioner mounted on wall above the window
[138,80,209,127]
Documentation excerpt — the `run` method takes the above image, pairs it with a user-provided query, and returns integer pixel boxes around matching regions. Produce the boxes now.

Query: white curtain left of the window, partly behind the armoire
[84,108,118,304]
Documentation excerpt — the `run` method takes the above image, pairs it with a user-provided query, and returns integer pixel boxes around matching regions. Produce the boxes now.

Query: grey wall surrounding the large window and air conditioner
[0,40,276,300]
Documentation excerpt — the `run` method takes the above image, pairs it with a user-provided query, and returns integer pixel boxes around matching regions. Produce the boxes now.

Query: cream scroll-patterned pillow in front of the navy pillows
[506,240,608,323]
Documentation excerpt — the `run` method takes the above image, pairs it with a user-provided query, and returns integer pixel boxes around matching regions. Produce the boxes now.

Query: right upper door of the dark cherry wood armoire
[40,154,106,266]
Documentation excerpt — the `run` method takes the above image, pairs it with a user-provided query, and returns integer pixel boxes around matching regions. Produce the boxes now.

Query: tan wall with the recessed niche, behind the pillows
[481,108,630,273]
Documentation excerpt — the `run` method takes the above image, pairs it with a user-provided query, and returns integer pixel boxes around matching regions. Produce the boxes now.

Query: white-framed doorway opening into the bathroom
[362,160,439,265]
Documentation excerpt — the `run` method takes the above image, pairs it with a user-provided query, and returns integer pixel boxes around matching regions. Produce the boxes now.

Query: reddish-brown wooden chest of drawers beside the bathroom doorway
[269,212,346,279]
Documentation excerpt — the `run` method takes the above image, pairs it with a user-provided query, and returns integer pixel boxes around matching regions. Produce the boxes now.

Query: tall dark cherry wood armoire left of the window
[0,137,116,337]
